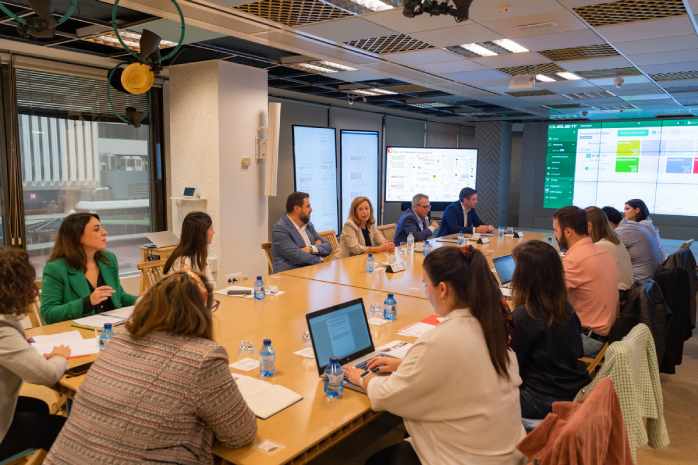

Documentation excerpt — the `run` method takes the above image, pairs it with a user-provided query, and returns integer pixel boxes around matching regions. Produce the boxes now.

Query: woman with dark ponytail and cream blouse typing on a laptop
[344,245,525,465]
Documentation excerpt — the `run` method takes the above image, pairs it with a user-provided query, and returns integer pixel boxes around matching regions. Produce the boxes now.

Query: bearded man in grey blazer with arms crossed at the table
[271,192,332,273]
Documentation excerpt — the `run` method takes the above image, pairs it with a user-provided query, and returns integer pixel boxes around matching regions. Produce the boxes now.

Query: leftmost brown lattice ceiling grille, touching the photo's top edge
[236,0,354,26]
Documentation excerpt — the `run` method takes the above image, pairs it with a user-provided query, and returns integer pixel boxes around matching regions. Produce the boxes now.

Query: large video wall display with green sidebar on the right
[543,119,698,215]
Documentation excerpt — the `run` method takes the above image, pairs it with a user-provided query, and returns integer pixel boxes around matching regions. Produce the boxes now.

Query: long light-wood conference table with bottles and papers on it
[27,228,544,465]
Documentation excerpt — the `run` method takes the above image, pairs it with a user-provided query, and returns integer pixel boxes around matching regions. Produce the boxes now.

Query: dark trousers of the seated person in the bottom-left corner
[0,396,65,460]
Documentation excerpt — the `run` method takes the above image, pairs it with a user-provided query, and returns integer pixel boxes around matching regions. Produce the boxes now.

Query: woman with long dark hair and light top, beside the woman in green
[163,212,216,288]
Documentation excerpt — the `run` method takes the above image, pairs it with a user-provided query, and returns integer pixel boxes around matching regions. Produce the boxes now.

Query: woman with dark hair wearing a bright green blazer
[41,213,137,324]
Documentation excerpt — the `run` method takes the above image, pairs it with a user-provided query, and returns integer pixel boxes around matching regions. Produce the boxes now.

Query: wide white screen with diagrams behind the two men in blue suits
[385,147,477,202]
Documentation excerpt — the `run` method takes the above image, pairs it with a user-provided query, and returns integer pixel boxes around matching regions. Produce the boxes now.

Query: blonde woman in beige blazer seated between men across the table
[334,197,395,260]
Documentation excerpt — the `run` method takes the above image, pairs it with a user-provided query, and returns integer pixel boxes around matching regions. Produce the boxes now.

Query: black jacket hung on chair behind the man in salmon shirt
[608,280,671,361]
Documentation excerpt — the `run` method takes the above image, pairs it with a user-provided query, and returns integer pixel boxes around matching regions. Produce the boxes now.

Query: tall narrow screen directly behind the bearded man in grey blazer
[293,126,339,232]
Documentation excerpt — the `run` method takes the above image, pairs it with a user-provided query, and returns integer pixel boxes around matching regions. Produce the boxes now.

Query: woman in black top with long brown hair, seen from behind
[511,241,591,419]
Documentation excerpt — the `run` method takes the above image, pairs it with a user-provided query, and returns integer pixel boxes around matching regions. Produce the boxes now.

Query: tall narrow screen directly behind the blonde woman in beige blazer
[340,131,378,224]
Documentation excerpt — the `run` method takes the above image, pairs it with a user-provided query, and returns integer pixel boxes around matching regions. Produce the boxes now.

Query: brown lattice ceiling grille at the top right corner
[574,0,686,27]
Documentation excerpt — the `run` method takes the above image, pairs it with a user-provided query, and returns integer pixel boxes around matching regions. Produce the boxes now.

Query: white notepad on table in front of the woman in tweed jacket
[231,373,303,420]
